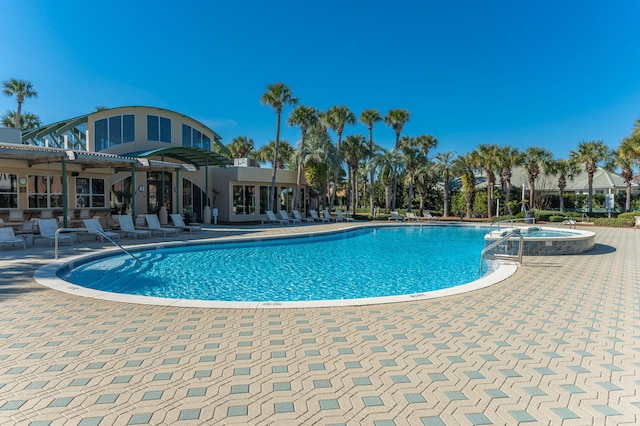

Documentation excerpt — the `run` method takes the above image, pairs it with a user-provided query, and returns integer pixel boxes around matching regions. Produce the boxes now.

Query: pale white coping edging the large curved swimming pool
[33,223,517,309]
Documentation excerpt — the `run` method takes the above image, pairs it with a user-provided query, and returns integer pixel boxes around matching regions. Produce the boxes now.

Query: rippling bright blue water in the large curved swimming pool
[60,226,486,301]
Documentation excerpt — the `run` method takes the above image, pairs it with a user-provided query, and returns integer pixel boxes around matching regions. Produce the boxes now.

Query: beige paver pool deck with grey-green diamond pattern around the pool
[0,224,640,426]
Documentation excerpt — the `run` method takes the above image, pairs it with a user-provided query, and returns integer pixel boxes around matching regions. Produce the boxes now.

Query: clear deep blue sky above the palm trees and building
[0,0,640,158]
